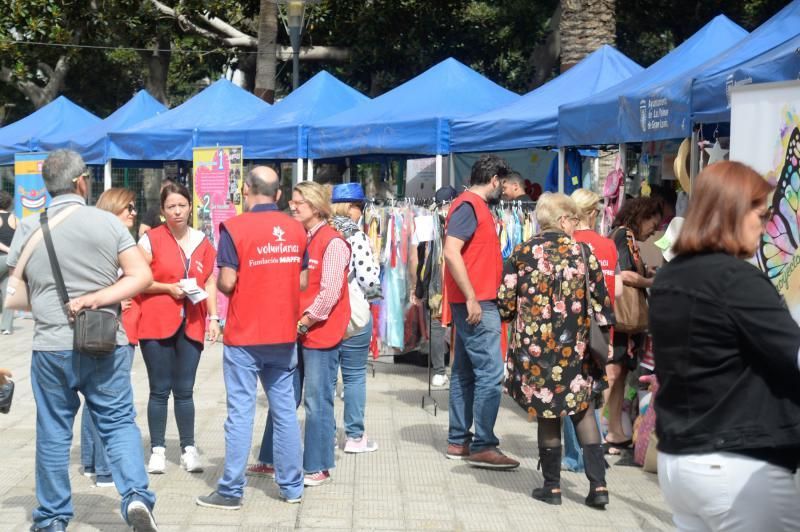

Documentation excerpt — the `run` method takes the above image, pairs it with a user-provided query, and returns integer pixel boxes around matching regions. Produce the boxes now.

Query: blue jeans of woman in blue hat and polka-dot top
[333,316,372,438]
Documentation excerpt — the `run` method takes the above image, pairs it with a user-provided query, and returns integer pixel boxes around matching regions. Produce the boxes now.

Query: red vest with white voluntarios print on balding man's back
[223,211,307,346]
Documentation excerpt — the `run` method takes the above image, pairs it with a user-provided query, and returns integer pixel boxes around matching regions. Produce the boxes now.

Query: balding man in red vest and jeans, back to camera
[197,166,307,510]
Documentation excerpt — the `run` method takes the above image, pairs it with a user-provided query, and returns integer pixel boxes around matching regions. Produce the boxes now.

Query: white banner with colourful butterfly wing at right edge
[730,81,800,323]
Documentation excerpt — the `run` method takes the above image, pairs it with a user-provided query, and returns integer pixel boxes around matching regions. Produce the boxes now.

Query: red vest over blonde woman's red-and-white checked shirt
[297,224,350,349]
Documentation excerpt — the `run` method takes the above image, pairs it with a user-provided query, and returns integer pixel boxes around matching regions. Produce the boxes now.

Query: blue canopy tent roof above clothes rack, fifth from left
[308,58,519,159]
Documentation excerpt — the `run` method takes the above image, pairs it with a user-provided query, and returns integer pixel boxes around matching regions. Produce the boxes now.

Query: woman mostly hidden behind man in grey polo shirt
[81,188,140,488]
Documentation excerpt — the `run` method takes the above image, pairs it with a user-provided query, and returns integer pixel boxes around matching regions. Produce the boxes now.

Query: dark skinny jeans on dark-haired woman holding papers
[140,325,203,449]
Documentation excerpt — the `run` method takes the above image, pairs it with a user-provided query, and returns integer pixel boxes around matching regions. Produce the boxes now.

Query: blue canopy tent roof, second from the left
[42,90,167,164]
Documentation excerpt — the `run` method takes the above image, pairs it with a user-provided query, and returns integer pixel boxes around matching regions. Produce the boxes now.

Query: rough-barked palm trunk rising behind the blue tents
[559,0,617,74]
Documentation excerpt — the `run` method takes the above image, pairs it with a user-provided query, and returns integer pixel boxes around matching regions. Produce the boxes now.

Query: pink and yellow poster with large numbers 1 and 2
[192,146,244,320]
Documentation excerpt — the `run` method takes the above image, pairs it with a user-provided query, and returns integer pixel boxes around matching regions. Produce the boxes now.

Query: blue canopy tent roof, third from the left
[108,79,269,161]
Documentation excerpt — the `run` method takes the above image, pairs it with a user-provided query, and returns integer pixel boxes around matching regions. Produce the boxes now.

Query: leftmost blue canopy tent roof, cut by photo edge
[0,96,100,165]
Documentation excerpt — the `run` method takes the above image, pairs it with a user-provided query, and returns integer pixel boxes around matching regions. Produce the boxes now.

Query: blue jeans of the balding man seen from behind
[217,345,303,499]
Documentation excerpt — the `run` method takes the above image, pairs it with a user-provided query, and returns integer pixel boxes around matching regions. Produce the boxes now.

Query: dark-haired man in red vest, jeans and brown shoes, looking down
[444,155,519,469]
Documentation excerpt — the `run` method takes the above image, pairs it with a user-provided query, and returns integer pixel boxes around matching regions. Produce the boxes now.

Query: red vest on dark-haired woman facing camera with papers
[138,224,216,344]
